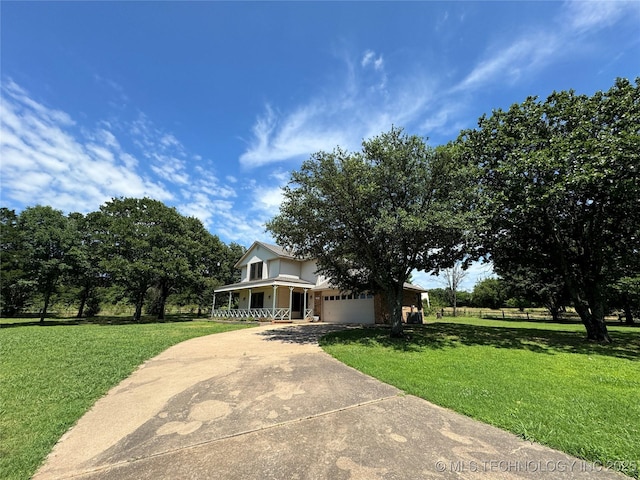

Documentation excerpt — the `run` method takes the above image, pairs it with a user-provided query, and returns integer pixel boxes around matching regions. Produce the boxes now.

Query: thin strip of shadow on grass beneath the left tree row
[0,314,207,328]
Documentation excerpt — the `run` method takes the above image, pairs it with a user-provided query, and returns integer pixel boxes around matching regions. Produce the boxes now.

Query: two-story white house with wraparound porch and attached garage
[211,242,425,324]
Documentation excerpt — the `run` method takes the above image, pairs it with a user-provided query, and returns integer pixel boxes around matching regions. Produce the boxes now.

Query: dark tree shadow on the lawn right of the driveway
[320,323,640,360]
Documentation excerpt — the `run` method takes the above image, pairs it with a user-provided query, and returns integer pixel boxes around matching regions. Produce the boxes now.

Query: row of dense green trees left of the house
[0,198,245,322]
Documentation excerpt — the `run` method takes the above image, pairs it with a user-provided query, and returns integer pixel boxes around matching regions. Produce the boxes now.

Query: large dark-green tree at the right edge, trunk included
[458,79,640,341]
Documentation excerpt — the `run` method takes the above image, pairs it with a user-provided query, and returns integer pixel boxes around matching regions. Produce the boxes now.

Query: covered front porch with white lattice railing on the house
[211,279,313,321]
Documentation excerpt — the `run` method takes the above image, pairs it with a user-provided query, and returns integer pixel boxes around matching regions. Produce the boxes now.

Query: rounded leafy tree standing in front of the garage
[267,128,476,335]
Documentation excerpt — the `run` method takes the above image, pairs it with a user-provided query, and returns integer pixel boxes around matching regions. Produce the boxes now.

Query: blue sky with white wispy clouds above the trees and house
[0,0,640,290]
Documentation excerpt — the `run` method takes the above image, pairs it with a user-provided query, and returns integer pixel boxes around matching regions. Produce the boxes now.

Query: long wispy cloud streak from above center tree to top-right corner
[240,2,640,168]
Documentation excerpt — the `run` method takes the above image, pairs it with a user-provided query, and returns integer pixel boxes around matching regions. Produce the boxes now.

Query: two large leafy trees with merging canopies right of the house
[267,79,640,342]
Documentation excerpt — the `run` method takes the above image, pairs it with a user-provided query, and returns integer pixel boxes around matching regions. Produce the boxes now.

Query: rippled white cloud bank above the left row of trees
[0,79,245,234]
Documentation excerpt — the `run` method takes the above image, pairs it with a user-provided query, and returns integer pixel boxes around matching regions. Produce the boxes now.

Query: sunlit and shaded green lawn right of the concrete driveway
[322,318,640,478]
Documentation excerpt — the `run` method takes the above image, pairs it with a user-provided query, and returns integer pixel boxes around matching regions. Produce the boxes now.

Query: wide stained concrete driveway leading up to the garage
[34,324,627,480]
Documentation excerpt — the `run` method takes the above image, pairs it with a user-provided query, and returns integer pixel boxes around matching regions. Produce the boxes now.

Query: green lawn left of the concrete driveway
[0,318,255,480]
